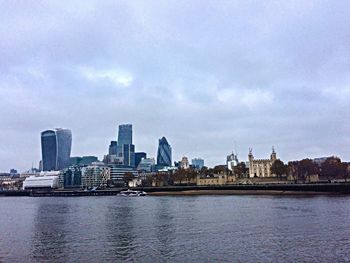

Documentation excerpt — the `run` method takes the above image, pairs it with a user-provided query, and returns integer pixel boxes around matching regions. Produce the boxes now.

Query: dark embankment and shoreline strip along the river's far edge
[0,183,350,197]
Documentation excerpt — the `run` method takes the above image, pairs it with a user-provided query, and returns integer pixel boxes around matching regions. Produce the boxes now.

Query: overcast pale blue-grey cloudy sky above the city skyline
[0,0,350,172]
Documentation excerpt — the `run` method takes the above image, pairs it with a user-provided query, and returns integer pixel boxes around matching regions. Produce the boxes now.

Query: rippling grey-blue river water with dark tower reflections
[0,196,350,262]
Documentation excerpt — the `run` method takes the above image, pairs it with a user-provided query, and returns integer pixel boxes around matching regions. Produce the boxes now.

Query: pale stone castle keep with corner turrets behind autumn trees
[248,147,277,178]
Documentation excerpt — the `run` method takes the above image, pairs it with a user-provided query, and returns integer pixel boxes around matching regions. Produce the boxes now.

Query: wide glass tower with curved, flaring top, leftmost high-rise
[41,129,72,171]
